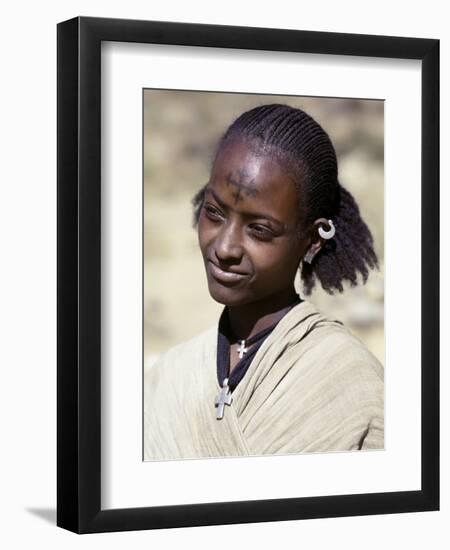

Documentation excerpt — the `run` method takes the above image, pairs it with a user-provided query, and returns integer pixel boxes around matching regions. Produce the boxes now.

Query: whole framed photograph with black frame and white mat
[57,17,439,533]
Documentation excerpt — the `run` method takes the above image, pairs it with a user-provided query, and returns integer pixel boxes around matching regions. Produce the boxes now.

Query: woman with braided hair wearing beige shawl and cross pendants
[144,104,384,460]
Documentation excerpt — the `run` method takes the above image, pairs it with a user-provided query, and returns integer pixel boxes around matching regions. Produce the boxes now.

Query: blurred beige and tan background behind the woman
[143,90,384,367]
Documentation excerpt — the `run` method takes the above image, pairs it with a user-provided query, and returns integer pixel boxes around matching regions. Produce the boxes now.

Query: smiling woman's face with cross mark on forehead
[198,142,310,306]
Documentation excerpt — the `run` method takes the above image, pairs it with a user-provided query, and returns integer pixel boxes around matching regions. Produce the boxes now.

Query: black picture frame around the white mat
[57,17,439,533]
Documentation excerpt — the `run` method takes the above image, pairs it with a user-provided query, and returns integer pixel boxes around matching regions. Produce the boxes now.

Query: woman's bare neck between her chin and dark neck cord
[228,287,297,340]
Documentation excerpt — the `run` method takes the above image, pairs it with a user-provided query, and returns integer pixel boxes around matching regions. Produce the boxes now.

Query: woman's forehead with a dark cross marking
[210,142,298,214]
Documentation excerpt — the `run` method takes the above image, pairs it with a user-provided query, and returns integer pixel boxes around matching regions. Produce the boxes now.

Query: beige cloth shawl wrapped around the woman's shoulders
[144,301,384,460]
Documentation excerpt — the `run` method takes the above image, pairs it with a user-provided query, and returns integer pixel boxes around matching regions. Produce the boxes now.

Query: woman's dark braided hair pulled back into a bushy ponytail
[192,104,378,295]
